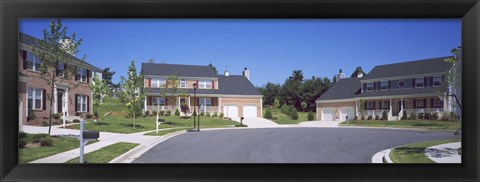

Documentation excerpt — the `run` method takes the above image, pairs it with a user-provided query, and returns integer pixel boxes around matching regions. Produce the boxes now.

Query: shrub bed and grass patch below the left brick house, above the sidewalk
[18,133,96,163]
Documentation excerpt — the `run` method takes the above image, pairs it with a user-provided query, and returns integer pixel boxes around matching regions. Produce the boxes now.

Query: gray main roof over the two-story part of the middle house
[142,63,217,78]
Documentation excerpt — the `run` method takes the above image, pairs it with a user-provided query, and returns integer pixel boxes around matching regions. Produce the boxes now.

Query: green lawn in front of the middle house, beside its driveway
[67,98,237,133]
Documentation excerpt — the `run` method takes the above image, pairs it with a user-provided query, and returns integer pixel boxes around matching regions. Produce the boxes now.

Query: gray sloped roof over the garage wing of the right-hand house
[318,78,360,100]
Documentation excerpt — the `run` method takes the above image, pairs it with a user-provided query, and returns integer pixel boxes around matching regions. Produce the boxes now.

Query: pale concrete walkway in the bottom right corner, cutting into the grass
[425,142,462,163]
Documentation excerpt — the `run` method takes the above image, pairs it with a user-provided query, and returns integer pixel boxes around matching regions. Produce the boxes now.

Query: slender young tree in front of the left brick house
[31,19,85,135]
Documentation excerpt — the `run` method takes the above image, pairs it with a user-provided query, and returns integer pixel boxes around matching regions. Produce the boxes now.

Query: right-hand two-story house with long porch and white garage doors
[316,57,460,121]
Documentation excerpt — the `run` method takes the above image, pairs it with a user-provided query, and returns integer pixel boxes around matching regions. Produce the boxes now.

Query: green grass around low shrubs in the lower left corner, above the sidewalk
[18,134,95,163]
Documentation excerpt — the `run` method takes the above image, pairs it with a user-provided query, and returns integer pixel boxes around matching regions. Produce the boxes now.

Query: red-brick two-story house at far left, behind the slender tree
[18,33,102,126]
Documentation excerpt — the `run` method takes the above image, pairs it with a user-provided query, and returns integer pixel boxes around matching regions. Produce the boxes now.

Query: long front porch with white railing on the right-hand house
[357,96,449,120]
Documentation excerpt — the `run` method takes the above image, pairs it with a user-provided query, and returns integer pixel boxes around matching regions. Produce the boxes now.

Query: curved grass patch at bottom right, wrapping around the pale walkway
[390,139,461,163]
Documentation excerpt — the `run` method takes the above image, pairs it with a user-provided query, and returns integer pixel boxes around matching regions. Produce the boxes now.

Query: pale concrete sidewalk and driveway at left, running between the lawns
[23,126,159,163]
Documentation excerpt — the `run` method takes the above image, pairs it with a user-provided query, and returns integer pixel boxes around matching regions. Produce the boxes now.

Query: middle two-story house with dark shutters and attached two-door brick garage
[142,63,262,118]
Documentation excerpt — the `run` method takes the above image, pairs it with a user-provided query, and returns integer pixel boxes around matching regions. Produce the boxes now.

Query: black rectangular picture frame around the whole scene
[0,0,480,182]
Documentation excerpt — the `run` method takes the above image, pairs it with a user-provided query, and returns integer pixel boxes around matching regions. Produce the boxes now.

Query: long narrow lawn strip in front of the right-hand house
[340,120,462,131]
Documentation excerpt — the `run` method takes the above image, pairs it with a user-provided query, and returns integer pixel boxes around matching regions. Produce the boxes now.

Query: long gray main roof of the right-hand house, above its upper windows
[361,56,452,80]
